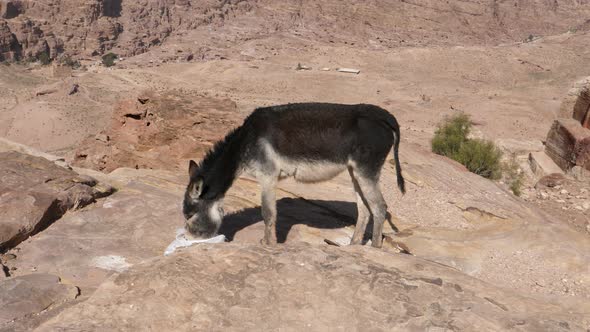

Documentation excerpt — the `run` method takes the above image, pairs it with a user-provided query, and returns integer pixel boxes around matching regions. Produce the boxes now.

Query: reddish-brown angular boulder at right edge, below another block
[545,119,590,170]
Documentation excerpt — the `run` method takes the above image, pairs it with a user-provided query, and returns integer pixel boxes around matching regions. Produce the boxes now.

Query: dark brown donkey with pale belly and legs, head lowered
[183,103,405,248]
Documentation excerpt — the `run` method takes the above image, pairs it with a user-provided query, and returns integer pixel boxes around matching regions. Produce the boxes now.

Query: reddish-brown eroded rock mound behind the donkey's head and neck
[73,91,243,172]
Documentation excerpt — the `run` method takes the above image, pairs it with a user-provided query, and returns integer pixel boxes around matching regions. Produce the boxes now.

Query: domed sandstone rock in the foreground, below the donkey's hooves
[36,244,590,331]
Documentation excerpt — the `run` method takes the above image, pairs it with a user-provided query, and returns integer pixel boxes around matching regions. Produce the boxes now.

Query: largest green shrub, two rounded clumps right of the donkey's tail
[432,113,502,180]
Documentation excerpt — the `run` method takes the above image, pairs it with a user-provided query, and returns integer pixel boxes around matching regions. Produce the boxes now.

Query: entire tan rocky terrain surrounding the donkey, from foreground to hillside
[0,1,590,331]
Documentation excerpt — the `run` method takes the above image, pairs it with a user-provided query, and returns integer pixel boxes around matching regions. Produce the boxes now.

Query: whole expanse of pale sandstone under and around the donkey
[0,141,590,330]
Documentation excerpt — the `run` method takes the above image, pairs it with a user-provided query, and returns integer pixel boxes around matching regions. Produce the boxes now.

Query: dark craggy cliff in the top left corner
[0,0,247,58]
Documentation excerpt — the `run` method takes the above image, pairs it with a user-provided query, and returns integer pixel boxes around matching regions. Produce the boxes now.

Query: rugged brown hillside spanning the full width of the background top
[0,0,590,61]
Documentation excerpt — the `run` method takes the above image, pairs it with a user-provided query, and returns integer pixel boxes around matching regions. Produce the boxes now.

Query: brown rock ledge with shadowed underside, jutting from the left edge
[0,152,112,251]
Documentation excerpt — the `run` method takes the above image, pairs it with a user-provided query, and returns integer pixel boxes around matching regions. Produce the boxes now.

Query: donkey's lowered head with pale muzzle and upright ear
[182,160,223,238]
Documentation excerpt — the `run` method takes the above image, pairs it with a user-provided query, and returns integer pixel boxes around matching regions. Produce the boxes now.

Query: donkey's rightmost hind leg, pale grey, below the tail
[355,172,387,248]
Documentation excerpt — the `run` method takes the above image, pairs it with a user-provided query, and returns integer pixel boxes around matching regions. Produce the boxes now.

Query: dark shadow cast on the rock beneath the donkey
[219,198,358,243]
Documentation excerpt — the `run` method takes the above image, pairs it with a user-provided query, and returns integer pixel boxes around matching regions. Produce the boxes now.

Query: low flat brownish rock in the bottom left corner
[0,273,78,328]
